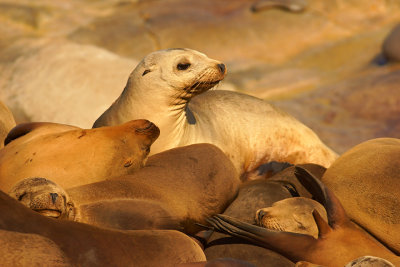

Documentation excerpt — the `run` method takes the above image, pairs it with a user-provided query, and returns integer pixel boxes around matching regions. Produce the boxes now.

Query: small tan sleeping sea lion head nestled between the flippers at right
[255,197,328,238]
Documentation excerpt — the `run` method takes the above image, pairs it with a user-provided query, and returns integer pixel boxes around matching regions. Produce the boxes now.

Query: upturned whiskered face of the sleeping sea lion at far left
[9,177,74,219]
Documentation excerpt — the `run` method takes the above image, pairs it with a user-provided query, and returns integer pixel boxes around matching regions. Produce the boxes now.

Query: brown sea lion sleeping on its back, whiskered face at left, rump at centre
[10,144,240,236]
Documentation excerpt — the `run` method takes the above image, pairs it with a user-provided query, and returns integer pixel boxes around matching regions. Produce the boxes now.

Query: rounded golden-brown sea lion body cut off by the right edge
[322,138,400,254]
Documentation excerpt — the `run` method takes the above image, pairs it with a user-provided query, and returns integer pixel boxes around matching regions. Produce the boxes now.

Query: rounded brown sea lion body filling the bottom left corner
[0,230,72,267]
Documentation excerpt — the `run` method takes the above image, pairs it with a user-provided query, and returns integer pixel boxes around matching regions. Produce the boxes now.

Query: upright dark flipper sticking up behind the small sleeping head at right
[294,166,350,228]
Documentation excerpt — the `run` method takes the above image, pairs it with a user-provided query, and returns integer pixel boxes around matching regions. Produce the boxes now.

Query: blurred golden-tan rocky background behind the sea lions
[0,0,400,153]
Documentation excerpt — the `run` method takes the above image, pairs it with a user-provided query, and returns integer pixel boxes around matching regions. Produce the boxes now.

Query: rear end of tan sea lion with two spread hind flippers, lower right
[208,167,400,266]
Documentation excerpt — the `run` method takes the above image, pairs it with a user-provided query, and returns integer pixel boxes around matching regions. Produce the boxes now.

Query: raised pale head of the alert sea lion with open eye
[127,48,226,105]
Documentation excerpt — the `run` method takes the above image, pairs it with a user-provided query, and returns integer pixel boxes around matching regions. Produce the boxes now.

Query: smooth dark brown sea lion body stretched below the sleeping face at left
[0,191,206,267]
